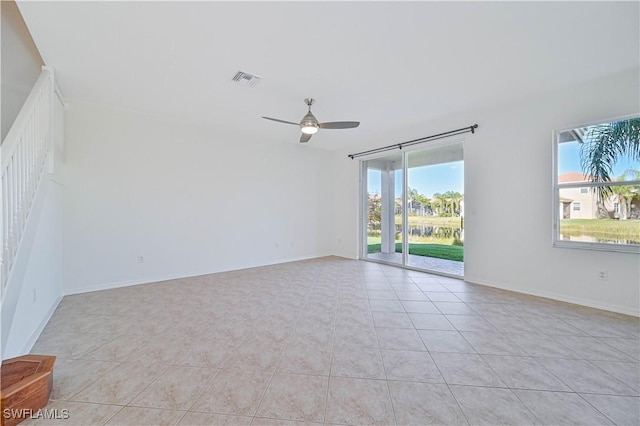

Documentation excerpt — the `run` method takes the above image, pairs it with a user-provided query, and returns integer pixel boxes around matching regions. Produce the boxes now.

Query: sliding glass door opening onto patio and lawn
[362,141,464,276]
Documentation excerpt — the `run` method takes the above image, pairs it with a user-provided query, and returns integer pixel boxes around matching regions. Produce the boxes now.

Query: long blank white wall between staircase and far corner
[64,101,333,294]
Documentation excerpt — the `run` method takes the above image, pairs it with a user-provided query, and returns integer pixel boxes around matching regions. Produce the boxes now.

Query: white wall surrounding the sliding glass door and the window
[332,69,640,315]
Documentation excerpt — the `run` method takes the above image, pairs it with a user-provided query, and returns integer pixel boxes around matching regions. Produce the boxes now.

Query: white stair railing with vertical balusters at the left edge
[0,67,63,300]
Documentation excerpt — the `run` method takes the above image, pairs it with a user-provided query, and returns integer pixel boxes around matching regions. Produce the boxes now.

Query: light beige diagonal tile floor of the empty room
[24,257,640,425]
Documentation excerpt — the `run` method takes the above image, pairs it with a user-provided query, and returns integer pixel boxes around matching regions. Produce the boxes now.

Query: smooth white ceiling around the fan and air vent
[19,1,640,149]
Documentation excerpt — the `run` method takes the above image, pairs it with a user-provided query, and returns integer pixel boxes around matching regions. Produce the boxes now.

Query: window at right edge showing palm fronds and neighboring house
[553,117,640,253]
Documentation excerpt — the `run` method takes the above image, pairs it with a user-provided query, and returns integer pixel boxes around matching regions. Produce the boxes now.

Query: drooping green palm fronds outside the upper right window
[580,118,640,200]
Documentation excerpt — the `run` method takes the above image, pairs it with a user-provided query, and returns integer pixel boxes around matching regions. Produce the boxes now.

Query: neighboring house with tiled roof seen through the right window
[558,172,640,219]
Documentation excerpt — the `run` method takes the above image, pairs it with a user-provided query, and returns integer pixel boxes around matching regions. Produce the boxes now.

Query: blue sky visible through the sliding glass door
[367,161,464,197]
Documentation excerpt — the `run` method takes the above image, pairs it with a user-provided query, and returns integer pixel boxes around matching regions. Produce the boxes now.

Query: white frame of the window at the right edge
[551,114,640,254]
